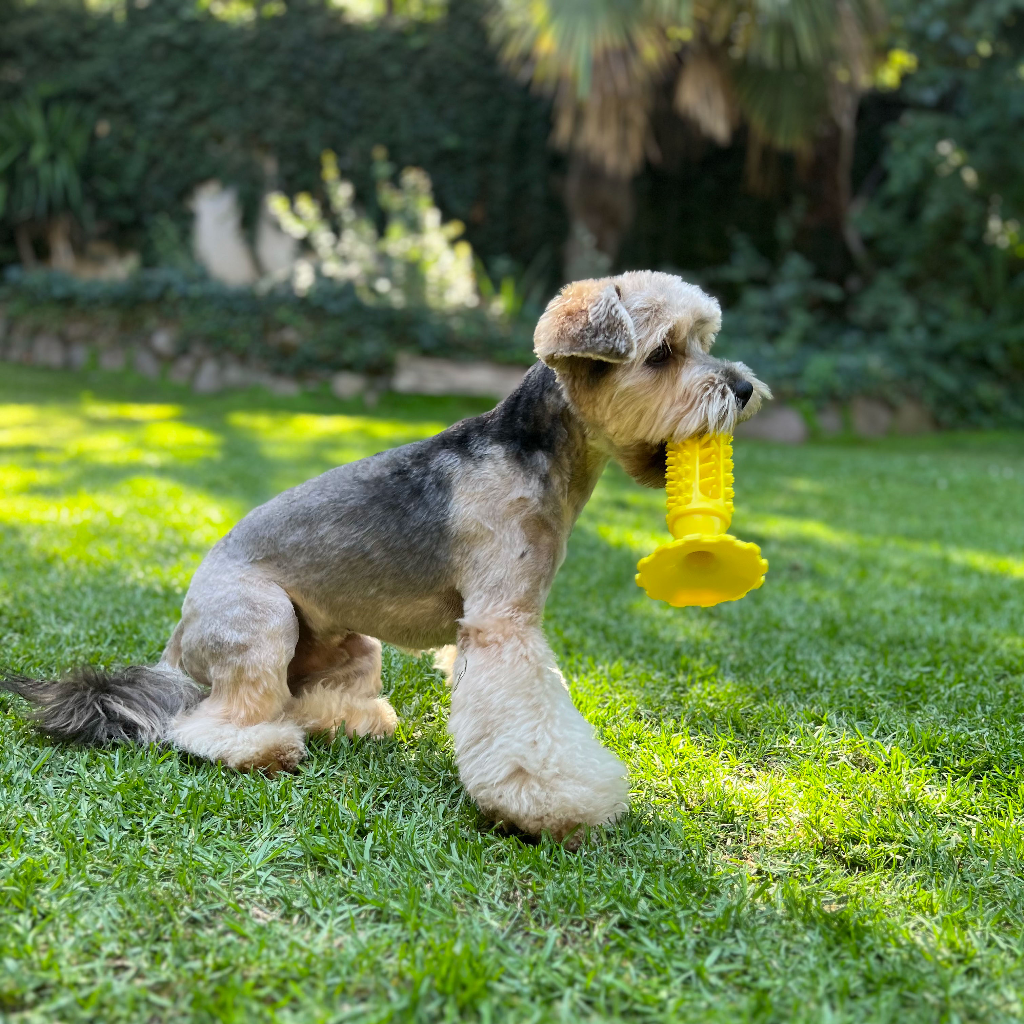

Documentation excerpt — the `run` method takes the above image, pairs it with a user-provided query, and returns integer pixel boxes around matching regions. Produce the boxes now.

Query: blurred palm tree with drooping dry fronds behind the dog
[490,0,884,278]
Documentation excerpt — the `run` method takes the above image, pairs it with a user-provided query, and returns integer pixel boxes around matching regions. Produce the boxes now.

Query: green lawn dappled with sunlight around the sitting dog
[0,367,1024,1024]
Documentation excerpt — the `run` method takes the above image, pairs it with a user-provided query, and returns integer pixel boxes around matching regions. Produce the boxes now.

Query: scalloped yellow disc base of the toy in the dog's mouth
[637,534,768,608]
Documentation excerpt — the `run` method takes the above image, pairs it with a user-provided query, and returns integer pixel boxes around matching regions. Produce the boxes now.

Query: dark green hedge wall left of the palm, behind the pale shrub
[0,0,566,271]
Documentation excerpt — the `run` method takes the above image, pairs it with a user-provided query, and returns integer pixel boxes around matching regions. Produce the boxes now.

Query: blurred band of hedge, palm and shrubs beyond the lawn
[0,0,1024,426]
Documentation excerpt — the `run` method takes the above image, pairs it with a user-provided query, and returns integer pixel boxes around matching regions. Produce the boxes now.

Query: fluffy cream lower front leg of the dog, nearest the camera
[449,607,629,840]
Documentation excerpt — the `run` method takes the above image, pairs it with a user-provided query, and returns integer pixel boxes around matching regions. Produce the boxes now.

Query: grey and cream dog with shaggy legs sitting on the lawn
[3,271,770,840]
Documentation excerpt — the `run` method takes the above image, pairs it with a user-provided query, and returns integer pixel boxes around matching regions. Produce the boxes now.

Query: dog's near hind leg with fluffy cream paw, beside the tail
[165,563,305,772]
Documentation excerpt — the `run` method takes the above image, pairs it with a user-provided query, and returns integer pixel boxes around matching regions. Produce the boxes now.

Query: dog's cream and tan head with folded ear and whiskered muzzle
[534,270,771,486]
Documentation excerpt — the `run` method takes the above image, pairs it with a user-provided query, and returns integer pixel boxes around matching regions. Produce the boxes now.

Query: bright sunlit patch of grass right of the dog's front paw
[573,667,1024,873]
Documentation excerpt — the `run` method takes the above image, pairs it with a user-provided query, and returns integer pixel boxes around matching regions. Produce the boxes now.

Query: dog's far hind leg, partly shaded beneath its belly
[289,631,398,737]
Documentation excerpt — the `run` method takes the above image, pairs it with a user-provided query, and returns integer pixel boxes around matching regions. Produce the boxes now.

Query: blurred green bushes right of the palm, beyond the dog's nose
[707,0,1024,426]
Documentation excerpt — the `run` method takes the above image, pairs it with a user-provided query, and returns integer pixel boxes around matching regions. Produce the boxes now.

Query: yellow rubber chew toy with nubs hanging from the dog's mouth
[637,434,768,608]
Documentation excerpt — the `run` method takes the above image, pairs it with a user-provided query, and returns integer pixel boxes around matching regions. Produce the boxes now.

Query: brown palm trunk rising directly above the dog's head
[563,152,634,281]
